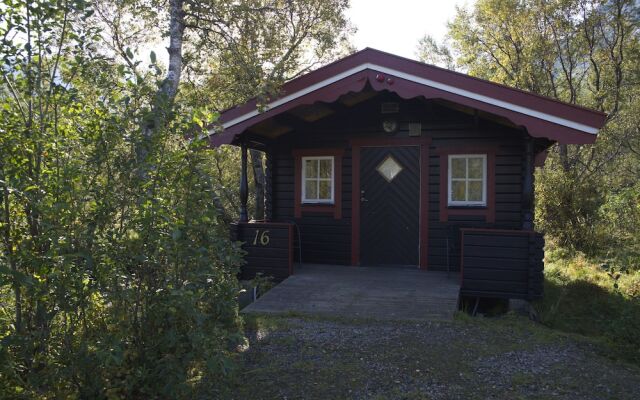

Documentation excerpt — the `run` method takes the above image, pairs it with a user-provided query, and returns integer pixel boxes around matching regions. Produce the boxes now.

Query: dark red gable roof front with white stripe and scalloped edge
[209,48,607,146]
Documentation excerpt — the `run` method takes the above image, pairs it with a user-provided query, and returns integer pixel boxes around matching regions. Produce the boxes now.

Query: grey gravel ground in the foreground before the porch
[233,316,640,400]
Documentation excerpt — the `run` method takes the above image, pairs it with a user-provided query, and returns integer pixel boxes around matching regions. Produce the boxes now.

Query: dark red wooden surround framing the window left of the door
[292,148,344,219]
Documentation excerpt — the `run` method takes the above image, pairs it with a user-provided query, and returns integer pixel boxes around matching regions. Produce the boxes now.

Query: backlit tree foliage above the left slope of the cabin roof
[180,0,352,109]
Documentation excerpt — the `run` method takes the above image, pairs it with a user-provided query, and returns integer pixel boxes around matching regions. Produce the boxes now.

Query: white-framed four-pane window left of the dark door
[302,157,334,204]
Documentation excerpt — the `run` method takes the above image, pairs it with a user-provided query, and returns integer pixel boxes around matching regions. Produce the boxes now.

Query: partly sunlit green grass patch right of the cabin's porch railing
[535,245,640,365]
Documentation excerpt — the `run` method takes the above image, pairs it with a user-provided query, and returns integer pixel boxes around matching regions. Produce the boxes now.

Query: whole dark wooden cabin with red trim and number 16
[209,49,606,300]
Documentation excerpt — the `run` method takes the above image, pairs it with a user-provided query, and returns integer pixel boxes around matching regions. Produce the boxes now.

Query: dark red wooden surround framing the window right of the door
[436,146,496,223]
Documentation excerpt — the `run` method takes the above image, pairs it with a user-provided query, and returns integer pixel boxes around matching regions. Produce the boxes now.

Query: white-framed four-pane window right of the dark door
[448,154,487,206]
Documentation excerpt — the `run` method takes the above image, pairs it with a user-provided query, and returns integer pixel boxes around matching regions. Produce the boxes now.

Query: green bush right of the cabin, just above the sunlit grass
[536,154,640,270]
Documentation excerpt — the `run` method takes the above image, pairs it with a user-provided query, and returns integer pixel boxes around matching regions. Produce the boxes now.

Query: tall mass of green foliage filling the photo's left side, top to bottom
[0,0,248,399]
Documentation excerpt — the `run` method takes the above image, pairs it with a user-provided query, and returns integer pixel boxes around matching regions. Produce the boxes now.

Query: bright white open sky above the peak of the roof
[347,0,475,59]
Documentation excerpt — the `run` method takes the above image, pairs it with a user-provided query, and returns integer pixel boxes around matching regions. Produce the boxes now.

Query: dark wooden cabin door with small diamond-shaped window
[360,146,420,266]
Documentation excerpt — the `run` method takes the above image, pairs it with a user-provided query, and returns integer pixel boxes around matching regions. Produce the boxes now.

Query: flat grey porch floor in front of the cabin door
[242,264,460,320]
